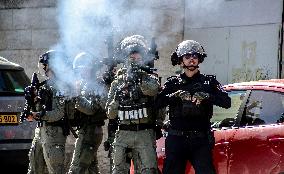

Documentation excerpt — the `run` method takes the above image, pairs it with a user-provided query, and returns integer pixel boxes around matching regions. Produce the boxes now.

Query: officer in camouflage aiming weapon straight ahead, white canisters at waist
[106,35,159,174]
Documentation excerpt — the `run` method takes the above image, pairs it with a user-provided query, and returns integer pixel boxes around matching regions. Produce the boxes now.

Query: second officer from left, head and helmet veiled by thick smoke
[68,52,107,174]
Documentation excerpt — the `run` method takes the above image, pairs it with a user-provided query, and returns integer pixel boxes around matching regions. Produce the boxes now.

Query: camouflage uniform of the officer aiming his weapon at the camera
[107,64,159,174]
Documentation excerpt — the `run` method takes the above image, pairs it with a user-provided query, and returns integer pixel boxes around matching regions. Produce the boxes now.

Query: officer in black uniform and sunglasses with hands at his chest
[156,40,231,174]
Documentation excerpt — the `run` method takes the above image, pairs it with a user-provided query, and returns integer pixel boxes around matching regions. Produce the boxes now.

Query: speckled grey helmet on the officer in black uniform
[171,40,207,66]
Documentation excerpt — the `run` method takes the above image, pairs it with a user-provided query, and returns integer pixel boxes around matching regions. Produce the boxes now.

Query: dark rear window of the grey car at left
[0,70,29,95]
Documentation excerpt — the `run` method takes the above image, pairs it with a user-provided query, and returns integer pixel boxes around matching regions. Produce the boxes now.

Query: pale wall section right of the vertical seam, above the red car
[184,0,283,84]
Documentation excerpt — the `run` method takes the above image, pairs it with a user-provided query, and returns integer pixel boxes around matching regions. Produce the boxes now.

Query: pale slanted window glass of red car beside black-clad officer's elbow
[211,91,246,127]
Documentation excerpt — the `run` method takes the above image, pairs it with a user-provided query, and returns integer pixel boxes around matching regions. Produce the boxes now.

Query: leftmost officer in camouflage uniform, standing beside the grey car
[28,50,69,174]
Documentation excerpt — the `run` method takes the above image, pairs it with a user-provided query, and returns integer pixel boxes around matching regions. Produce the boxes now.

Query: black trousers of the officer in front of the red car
[163,131,216,174]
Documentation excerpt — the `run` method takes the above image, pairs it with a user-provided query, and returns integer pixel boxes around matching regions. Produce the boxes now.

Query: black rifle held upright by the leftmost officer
[20,72,39,122]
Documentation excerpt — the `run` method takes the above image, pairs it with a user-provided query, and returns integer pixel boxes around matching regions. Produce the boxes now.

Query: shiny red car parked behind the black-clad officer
[157,79,284,174]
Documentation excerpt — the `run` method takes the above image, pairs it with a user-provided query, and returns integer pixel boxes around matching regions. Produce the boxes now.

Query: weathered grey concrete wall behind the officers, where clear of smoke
[0,0,283,173]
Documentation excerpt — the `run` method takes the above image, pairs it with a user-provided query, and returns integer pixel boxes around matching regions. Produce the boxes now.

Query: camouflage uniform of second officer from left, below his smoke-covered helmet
[69,81,107,174]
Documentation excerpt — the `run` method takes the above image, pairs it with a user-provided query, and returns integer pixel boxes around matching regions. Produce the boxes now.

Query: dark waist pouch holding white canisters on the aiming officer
[118,103,148,120]
